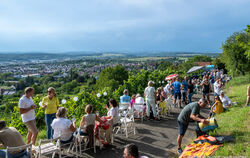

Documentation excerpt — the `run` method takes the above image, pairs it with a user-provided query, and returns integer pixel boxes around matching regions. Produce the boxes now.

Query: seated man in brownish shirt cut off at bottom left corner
[0,120,29,158]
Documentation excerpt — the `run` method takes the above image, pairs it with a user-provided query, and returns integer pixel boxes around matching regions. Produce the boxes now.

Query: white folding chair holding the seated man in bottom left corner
[5,144,32,158]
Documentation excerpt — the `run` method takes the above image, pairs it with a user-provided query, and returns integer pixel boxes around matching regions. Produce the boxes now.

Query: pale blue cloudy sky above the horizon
[0,0,250,53]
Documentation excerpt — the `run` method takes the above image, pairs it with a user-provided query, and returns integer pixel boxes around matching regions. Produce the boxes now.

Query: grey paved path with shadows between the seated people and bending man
[77,95,212,158]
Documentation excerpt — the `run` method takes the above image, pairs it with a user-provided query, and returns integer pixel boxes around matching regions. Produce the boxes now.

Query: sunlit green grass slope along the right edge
[211,74,250,156]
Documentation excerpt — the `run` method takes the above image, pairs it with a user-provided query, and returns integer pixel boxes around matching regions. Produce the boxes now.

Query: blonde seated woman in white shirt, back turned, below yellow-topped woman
[51,107,76,144]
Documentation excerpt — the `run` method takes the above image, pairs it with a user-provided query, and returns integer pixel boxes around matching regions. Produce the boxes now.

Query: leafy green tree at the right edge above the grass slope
[221,26,250,76]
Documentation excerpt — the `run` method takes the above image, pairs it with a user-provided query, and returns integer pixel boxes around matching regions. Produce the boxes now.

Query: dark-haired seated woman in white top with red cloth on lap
[100,98,120,145]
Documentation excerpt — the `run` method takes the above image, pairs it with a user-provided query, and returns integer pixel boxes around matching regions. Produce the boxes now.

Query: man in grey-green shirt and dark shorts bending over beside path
[177,98,208,154]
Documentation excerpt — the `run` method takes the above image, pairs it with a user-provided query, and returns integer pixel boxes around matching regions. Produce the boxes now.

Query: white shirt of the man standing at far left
[19,95,35,122]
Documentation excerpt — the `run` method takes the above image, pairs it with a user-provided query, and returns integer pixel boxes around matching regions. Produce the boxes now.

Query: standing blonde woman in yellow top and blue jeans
[42,87,59,139]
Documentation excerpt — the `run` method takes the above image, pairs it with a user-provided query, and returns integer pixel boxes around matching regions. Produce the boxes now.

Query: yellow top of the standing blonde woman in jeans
[42,96,59,114]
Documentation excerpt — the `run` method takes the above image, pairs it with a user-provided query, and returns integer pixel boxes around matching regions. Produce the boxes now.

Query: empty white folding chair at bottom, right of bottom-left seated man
[34,137,62,158]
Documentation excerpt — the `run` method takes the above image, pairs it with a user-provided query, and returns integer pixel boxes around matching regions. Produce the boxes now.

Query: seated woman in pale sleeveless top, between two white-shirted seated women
[80,104,102,135]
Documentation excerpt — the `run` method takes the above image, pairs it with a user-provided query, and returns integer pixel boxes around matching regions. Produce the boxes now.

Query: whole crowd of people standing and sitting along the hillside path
[0,68,238,157]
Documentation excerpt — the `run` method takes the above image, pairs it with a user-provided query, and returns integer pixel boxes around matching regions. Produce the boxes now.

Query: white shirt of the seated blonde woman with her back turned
[51,118,73,141]
